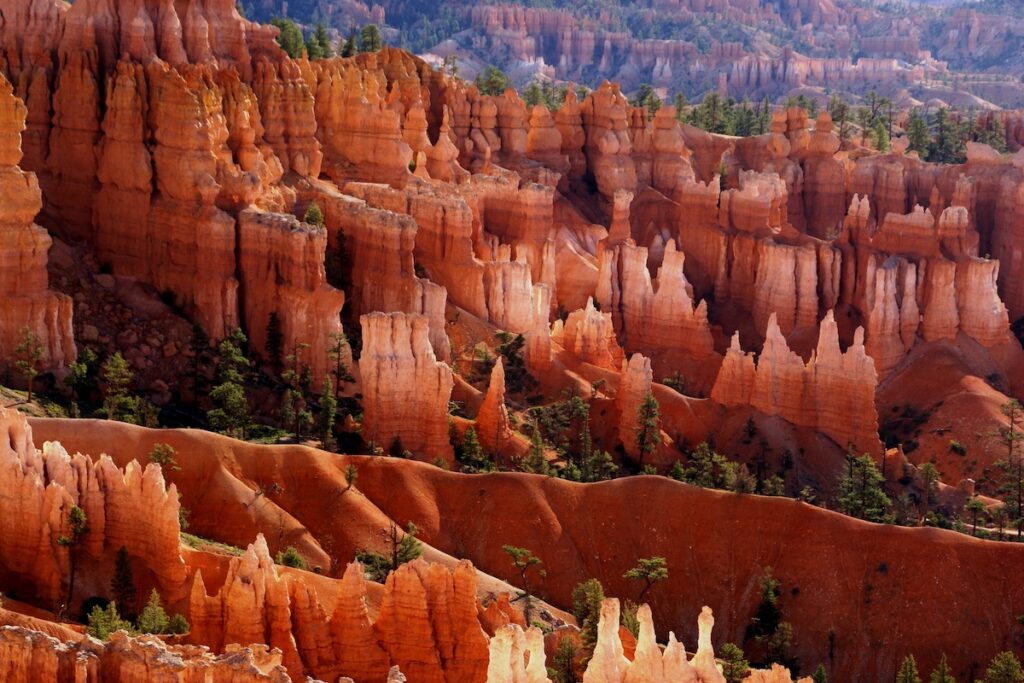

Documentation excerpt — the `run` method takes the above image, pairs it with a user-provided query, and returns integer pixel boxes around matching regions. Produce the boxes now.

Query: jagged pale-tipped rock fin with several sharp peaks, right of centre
[711,311,881,454]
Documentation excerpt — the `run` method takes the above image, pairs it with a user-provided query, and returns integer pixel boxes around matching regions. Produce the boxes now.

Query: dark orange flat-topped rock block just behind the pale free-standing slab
[239,210,352,384]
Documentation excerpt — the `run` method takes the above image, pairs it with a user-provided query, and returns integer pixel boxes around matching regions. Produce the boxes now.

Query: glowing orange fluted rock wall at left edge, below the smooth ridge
[0,408,185,610]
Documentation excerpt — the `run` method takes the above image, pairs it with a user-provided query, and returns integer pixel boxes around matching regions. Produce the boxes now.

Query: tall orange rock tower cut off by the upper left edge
[0,75,77,374]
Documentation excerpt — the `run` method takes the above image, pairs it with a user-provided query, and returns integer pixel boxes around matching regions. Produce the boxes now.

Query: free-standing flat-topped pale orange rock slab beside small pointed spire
[359,312,455,465]
